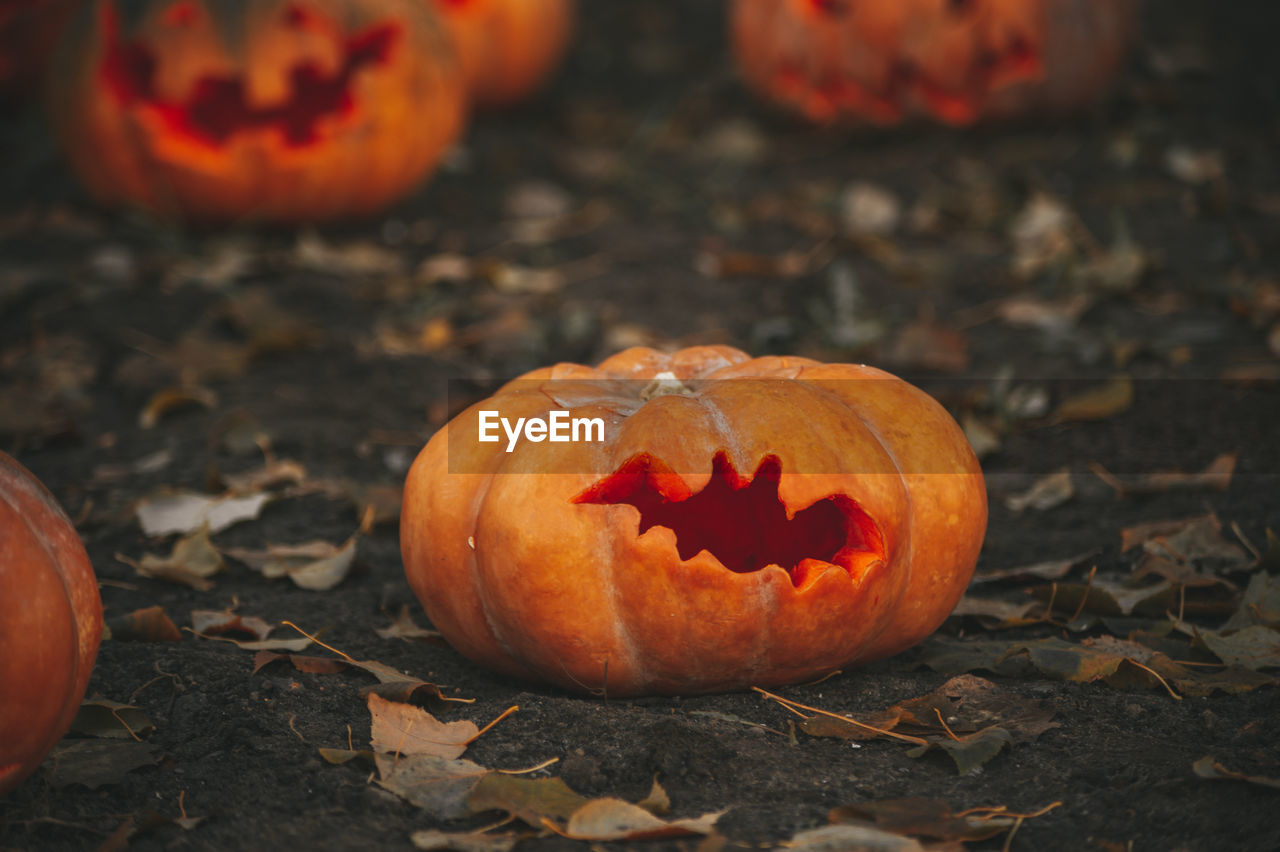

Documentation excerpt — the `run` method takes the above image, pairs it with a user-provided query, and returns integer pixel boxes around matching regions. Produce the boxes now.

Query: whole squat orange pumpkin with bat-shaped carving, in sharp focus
[401,347,987,696]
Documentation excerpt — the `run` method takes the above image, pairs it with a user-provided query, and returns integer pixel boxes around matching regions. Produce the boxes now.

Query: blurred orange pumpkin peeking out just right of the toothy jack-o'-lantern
[433,0,573,106]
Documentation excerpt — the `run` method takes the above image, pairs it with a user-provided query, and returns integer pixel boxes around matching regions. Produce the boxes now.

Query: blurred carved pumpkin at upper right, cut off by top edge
[731,0,1138,124]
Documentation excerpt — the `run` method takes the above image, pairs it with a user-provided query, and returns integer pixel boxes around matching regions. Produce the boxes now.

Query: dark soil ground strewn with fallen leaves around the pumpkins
[0,0,1280,851]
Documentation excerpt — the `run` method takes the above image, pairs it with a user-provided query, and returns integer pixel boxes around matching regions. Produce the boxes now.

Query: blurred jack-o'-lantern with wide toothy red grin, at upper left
[50,0,465,221]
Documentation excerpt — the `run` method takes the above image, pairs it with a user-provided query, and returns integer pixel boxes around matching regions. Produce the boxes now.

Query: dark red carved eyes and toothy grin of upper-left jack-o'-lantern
[101,4,399,147]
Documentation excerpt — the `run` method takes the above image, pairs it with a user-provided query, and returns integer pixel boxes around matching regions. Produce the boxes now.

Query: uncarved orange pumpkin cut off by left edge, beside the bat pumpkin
[0,453,102,794]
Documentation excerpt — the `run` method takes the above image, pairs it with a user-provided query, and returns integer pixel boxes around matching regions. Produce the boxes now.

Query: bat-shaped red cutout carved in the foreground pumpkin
[573,453,884,586]
